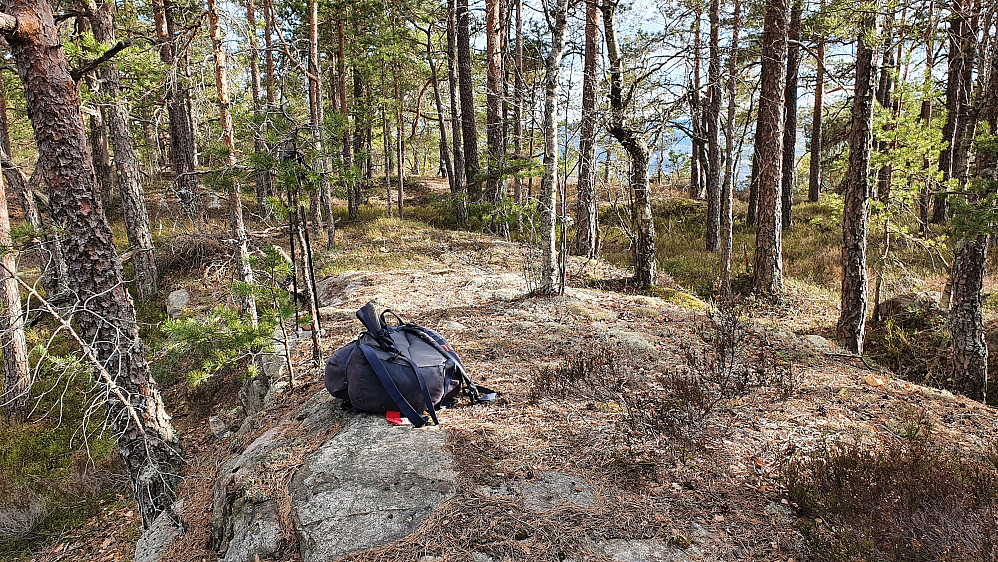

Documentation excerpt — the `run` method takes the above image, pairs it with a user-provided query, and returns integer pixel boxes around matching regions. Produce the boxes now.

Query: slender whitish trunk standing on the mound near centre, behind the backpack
[537,0,568,295]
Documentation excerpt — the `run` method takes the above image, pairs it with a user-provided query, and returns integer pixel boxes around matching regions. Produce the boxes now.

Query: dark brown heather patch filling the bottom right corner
[783,404,998,562]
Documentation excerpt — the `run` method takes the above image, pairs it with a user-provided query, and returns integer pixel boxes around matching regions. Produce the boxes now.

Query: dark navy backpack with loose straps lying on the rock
[324,303,499,427]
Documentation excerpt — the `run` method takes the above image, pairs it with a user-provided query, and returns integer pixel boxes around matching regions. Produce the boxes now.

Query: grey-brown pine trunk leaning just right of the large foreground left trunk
[84,1,159,299]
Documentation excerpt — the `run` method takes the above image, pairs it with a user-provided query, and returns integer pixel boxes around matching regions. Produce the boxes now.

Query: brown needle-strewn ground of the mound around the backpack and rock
[5,177,998,562]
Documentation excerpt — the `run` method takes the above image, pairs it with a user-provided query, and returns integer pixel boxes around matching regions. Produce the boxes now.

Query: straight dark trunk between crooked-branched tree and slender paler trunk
[705,0,730,252]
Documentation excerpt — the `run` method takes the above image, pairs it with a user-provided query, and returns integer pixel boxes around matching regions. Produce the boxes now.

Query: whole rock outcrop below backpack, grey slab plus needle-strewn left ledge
[211,390,455,562]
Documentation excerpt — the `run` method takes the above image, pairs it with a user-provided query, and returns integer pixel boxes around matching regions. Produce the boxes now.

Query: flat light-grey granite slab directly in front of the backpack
[290,416,455,562]
